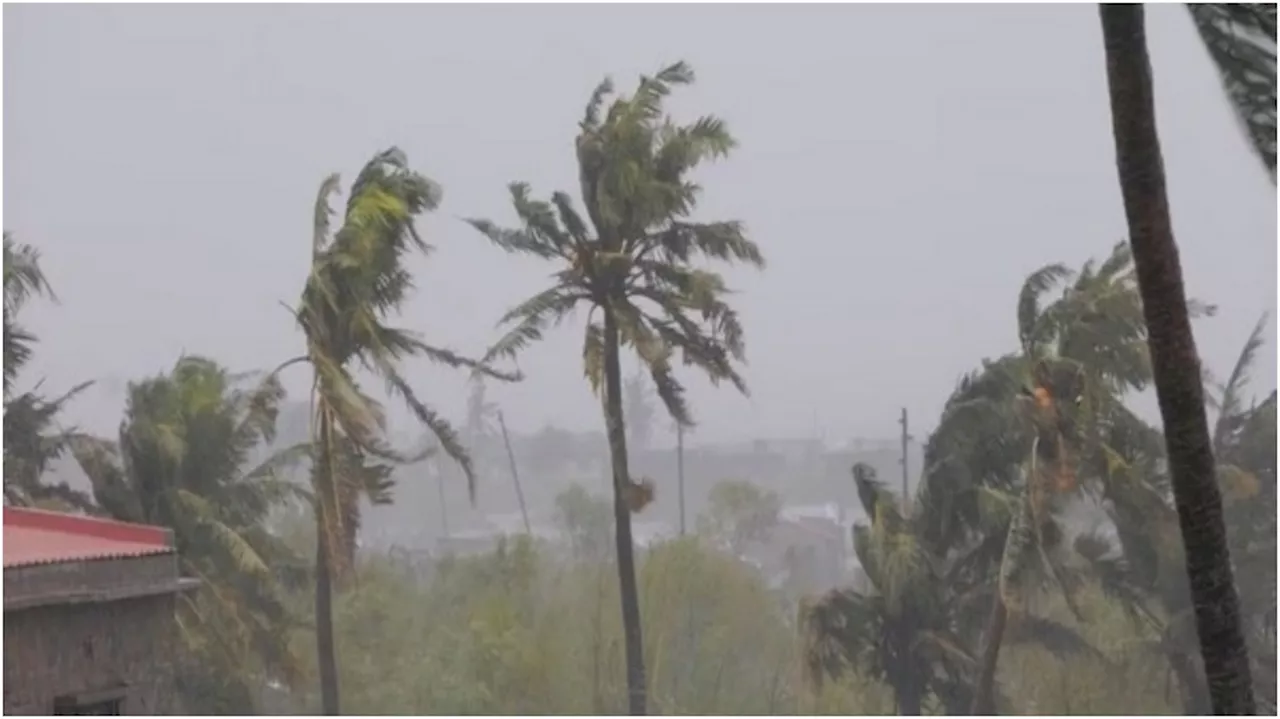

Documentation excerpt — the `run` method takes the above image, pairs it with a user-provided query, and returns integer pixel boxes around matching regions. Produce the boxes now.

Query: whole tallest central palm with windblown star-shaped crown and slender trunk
[468,63,764,714]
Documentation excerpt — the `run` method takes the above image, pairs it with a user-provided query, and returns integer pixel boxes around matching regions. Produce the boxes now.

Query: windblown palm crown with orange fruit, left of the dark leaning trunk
[920,243,1182,554]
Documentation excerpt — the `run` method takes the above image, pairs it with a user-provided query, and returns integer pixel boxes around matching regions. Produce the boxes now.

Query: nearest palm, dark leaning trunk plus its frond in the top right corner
[1100,5,1276,714]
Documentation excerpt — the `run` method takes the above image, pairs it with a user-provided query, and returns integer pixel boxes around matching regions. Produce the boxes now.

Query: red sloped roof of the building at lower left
[4,507,173,569]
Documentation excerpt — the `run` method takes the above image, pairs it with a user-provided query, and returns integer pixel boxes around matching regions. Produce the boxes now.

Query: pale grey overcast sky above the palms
[4,4,1276,440]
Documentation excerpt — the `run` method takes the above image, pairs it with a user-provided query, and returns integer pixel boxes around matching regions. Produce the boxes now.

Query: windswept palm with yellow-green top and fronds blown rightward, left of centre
[276,148,515,714]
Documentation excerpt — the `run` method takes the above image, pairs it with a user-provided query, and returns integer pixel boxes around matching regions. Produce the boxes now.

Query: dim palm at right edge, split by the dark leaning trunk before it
[1076,317,1276,714]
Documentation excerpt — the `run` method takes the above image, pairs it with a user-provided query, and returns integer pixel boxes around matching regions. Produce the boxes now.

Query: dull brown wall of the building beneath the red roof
[4,594,177,714]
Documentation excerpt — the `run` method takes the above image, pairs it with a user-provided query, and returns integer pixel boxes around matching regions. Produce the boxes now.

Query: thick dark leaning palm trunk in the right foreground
[1098,5,1254,714]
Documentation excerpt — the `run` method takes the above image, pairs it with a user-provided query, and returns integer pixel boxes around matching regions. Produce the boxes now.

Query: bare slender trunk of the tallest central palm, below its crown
[604,311,646,715]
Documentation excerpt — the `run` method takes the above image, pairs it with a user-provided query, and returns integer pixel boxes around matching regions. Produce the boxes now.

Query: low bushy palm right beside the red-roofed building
[73,357,306,714]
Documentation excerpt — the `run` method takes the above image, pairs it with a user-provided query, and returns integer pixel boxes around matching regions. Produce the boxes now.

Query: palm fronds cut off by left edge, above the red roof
[4,232,92,510]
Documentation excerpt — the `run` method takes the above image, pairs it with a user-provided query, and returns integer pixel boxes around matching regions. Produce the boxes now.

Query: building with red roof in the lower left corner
[4,507,195,715]
